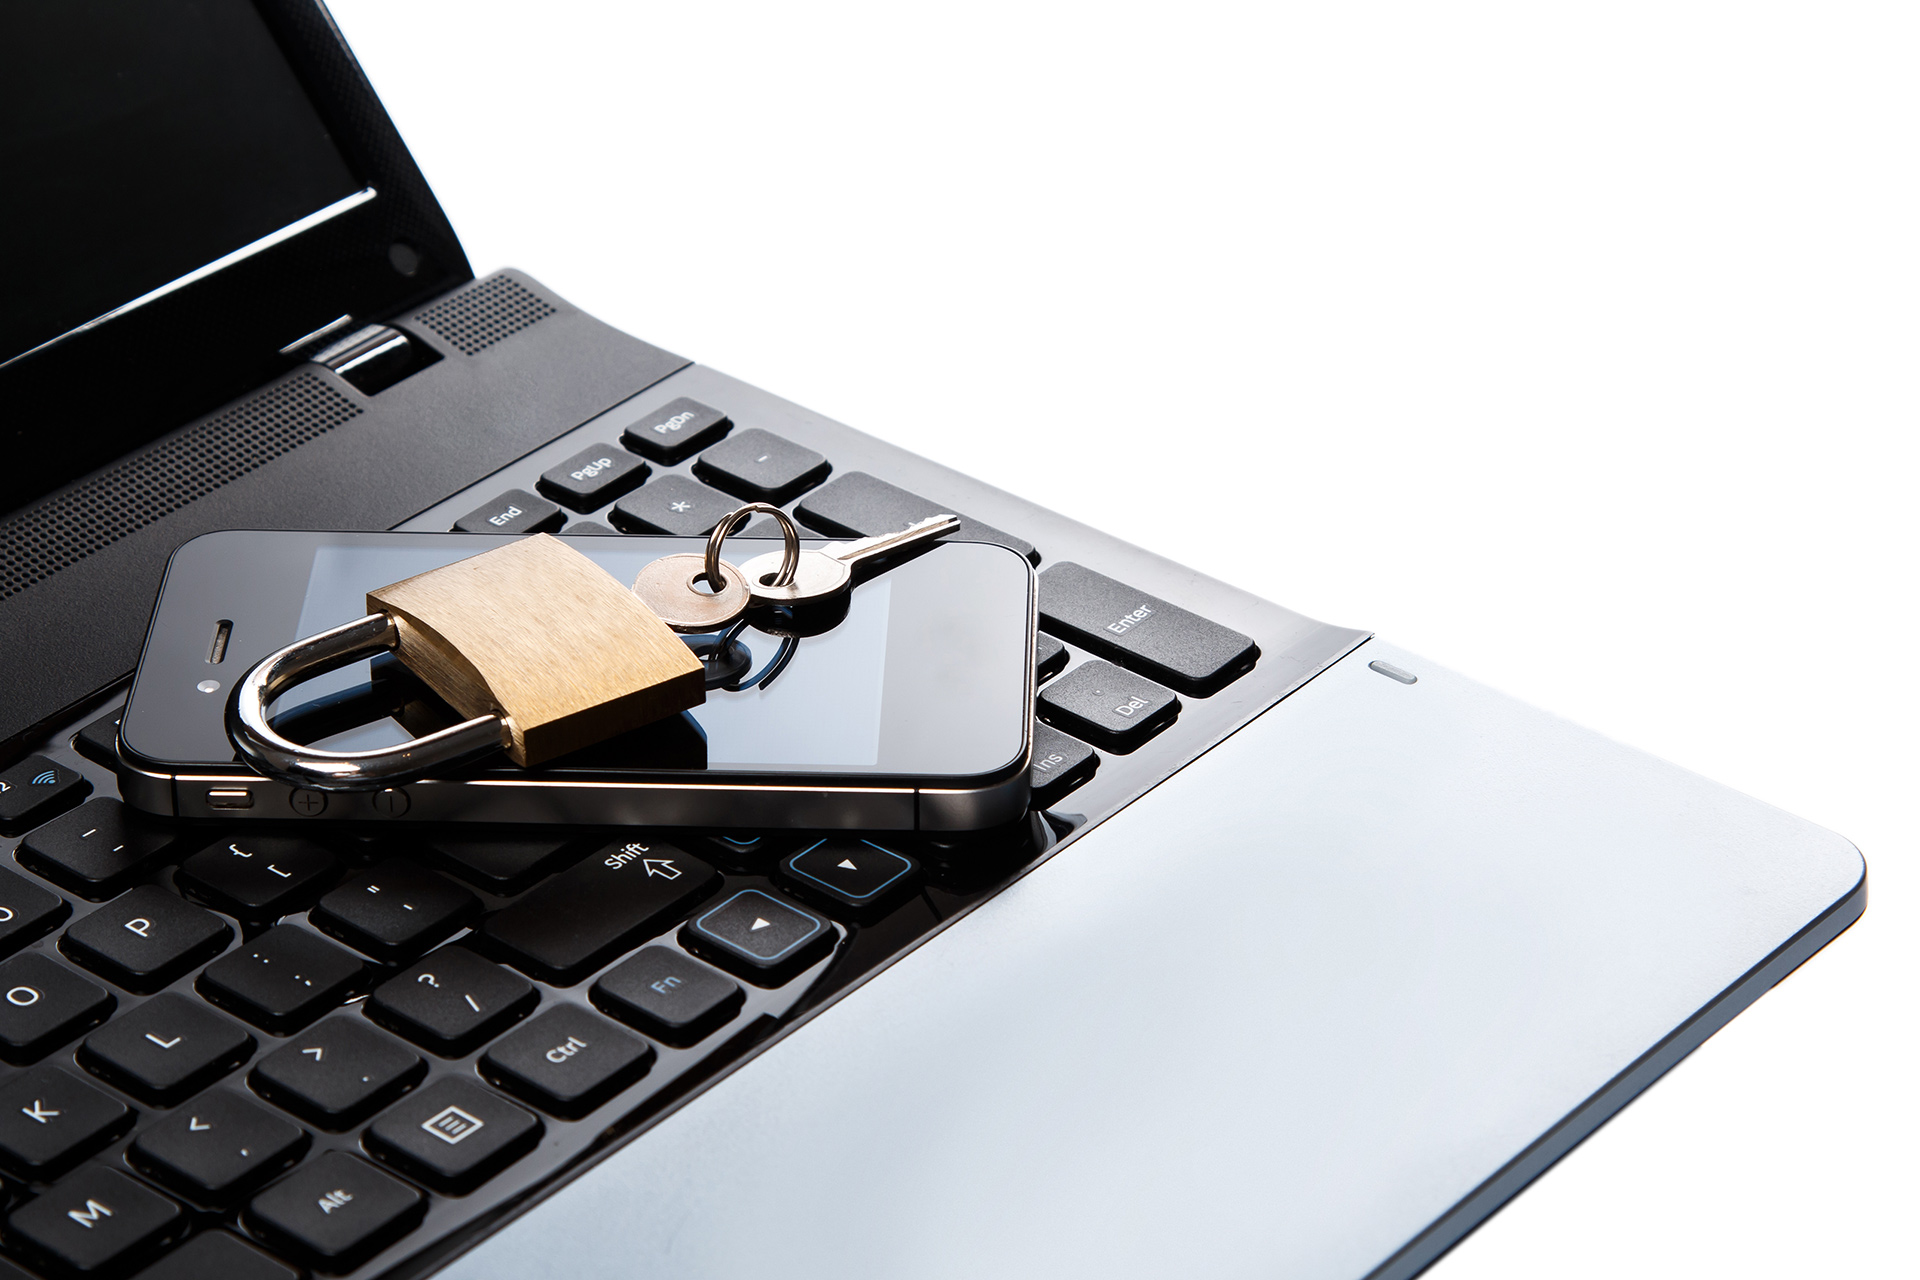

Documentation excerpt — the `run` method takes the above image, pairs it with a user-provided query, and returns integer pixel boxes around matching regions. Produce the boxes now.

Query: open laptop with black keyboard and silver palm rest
[0,0,1864,1276]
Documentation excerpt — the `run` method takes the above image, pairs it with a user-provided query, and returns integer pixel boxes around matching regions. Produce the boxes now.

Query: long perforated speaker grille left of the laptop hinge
[0,374,361,601]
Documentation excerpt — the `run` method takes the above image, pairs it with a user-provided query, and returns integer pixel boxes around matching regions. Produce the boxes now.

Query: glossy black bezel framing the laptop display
[0,0,472,512]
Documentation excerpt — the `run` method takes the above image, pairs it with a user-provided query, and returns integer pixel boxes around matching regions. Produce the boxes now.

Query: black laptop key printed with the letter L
[79,990,253,1105]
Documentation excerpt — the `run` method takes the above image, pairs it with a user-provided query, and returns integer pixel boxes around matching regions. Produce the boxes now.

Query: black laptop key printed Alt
[246,1151,426,1270]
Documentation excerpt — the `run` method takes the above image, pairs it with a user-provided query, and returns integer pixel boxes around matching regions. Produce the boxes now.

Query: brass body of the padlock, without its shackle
[367,533,707,764]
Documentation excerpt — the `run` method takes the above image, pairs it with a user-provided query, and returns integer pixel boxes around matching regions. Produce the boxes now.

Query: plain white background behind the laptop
[322,0,1920,1280]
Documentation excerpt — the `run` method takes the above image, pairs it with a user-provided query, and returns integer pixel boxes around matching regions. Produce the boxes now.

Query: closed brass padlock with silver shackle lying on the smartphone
[227,533,707,791]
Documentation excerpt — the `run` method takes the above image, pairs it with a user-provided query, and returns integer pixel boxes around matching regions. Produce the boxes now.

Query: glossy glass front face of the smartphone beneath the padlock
[121,532,1033,785]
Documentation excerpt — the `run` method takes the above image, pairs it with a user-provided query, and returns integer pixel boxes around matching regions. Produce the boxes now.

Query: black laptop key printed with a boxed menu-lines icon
[367,1077,545,1194]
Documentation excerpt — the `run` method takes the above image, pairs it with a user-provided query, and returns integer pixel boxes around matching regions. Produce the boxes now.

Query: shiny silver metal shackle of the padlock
[227,614,513,791]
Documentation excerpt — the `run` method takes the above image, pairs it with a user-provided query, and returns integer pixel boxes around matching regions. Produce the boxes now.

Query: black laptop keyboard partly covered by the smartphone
[0,364,1336,1280]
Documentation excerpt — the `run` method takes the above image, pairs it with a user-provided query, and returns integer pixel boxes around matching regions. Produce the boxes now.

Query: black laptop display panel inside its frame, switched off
[0,0,371,363]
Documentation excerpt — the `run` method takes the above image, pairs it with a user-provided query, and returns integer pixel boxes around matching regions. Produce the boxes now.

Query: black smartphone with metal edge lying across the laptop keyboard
[119,530,1037,831]
